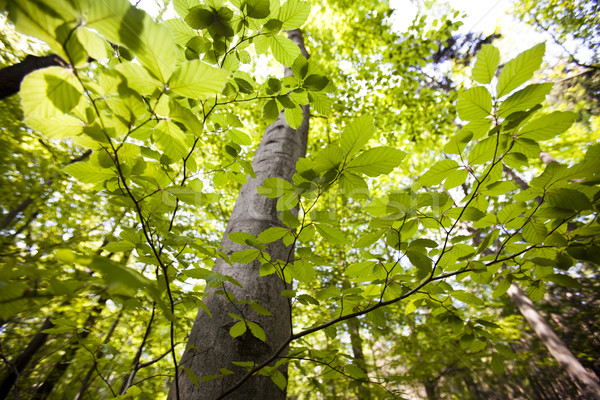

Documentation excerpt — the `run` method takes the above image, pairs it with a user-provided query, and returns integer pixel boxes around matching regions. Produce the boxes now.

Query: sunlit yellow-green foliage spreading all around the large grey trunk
[0,0,600,398]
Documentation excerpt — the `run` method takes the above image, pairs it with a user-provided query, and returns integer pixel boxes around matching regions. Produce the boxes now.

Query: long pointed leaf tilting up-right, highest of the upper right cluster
[496,43,546,98]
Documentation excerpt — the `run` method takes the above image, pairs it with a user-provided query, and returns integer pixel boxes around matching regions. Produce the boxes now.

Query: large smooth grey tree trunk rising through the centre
[169,29,309,400]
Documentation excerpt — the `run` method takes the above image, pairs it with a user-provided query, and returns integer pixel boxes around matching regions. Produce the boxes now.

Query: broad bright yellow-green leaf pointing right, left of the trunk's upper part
[169,60,229,98]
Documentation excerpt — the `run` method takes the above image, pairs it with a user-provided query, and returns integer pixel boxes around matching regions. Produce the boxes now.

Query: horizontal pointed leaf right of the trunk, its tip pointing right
[345,146,406,176]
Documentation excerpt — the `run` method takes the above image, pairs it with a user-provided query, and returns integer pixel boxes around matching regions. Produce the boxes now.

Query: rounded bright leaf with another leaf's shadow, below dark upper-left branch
[20,67,83,118]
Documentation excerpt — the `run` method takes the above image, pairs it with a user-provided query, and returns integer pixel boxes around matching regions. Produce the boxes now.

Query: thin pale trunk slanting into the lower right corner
[508,283,600,400]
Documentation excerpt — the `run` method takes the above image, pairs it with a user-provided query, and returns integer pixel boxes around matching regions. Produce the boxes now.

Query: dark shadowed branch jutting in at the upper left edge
[0,54,67,99]
